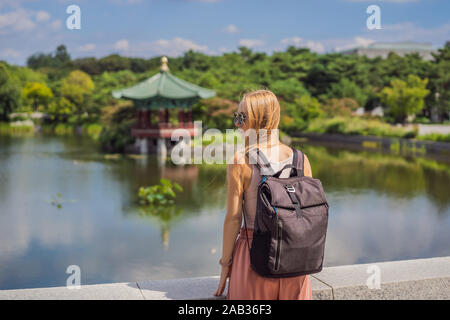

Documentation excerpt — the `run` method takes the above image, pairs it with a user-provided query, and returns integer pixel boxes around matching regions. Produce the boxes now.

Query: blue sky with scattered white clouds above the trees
[0,0,450,65]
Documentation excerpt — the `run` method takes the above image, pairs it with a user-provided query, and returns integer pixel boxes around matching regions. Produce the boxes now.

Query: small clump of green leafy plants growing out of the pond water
[138,178,183,206]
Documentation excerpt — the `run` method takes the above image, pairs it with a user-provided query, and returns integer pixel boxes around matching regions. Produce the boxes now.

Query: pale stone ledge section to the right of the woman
[313,257,450,299]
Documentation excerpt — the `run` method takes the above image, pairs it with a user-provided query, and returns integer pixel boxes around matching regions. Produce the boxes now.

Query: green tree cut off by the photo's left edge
[0,63,20,121]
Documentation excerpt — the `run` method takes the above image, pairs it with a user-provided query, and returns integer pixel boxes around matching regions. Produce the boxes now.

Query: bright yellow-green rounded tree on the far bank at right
[380,75,430,123]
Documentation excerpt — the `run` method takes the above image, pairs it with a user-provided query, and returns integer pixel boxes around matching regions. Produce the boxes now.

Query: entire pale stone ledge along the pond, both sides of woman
[0,257,450,300]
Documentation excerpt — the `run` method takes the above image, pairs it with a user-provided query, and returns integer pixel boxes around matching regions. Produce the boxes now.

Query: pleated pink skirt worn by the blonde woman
[227,228,312,300]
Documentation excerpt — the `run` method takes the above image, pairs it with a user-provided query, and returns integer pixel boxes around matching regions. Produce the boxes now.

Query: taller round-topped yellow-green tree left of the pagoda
[61,70,94,120]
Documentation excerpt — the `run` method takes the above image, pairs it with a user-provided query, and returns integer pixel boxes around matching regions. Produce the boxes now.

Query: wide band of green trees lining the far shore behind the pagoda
[0,44,444,140]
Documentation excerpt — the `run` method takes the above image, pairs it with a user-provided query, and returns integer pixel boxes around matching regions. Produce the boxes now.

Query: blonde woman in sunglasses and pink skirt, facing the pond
[214,90,312,300]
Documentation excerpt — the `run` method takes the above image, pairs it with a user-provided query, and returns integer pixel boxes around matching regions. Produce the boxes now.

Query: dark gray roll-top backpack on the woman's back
[243,148,329,278]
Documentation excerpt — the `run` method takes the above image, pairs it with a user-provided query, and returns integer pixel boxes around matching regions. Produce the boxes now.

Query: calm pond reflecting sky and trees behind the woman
[0,136,450,289]
